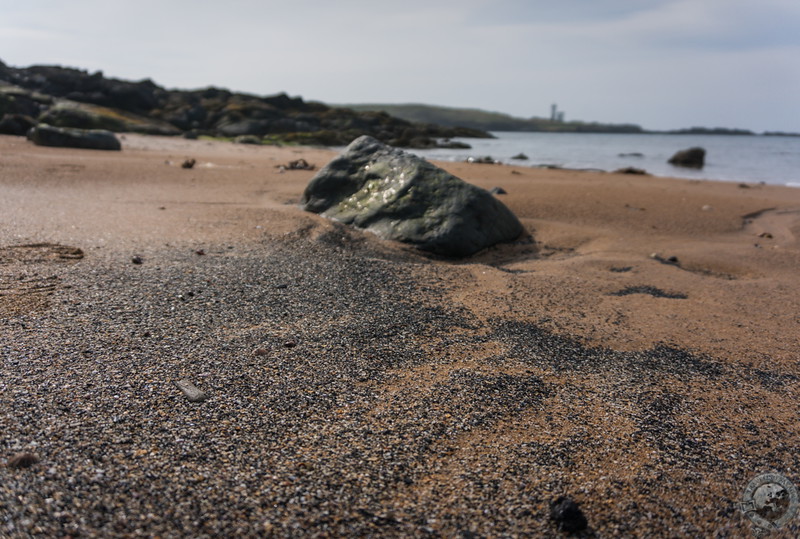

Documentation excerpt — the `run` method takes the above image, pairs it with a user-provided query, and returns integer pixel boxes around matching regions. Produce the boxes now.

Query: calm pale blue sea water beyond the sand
[412,132,800,187]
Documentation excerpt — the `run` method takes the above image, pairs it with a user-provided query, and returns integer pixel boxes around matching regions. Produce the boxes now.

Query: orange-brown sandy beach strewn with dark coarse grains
[0,134,800,537]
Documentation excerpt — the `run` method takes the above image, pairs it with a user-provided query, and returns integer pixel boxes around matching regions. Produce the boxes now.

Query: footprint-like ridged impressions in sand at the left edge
[0,243,83,317]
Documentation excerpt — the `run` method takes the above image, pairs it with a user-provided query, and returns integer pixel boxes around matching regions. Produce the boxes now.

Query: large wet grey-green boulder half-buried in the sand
[302,136,524,257]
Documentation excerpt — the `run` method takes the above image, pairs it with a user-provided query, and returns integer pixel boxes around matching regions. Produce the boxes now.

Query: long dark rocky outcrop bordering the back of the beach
[0,62,491,148]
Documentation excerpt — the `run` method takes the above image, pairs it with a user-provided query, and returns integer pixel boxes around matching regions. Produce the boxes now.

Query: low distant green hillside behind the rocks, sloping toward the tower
[338,103,644,133]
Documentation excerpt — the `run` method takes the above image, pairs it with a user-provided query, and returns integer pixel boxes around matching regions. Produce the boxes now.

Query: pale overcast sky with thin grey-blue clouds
[0,0,800,132]
